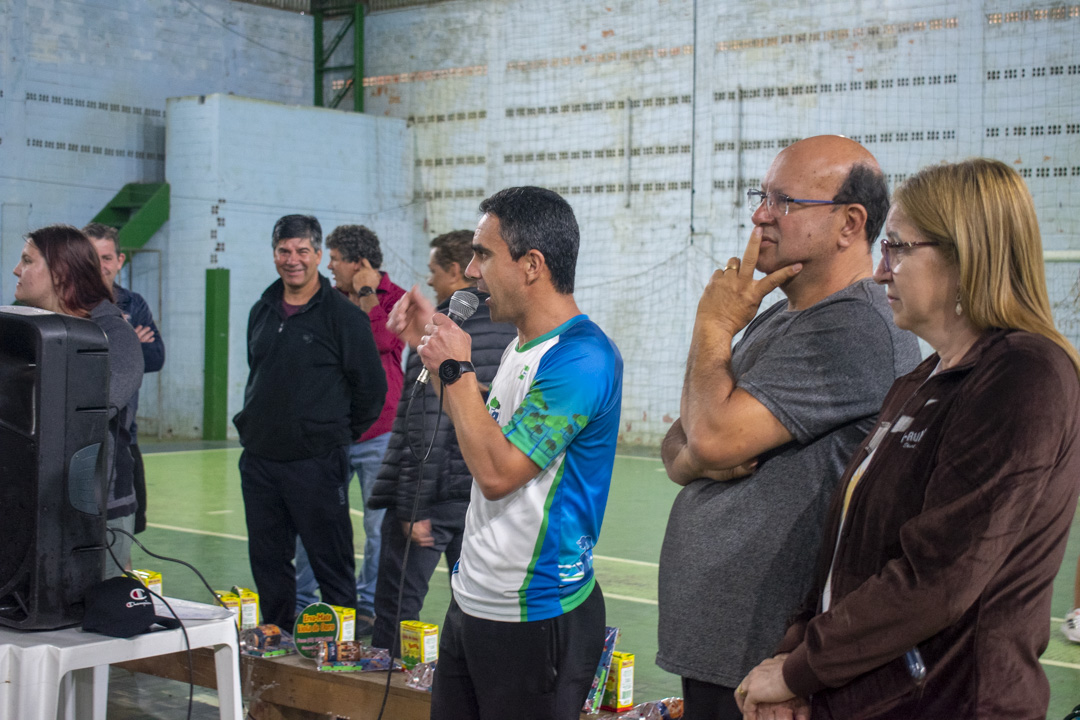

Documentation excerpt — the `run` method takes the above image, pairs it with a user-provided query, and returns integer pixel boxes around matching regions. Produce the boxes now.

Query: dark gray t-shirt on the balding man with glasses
[657,279,920,687]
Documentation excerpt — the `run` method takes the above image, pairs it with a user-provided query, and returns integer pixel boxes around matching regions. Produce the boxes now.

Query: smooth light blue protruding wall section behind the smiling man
[163,94,414,436]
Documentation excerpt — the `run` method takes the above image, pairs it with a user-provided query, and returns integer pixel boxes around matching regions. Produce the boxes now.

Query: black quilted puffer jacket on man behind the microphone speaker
[367,293,517,520]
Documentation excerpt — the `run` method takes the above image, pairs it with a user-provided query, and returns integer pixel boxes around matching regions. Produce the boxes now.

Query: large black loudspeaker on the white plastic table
[0,307,109,629]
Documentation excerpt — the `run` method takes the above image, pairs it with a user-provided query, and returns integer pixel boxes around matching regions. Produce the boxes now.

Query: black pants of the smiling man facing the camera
[240,447,356,633]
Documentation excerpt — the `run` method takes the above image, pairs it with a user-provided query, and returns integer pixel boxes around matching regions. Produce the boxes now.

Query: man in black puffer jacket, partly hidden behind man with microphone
[365,230,517,655]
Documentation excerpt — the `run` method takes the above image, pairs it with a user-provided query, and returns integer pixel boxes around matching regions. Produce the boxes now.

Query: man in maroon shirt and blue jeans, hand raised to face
[296,225,405,638]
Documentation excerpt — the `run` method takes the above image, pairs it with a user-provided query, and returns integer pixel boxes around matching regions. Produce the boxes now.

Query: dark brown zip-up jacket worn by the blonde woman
[779,330,1080,720]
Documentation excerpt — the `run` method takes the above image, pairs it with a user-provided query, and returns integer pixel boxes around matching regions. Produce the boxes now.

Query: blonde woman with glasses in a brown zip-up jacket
[735,159,1080,720]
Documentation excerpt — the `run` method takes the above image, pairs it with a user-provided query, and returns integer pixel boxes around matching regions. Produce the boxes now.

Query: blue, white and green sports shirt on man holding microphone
[451,315,622,622]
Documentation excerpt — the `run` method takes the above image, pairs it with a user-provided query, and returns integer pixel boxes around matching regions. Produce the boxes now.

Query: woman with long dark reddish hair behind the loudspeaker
[14,225,143,578]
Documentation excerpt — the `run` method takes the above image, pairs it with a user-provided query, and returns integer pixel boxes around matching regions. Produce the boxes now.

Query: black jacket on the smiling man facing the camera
[232,275,387,461]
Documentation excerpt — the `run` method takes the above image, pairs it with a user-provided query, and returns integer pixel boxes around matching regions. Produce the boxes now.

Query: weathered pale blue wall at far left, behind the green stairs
[0,0,312,435]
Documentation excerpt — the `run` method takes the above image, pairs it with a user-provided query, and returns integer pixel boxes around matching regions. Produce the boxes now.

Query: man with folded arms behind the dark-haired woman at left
[82,222,165,533]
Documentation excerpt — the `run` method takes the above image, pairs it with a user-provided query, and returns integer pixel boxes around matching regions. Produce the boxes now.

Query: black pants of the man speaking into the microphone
[431,584,605,720]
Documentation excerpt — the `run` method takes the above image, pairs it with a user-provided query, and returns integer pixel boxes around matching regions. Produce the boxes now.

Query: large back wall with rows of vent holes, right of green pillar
[365,0,1080,445]
